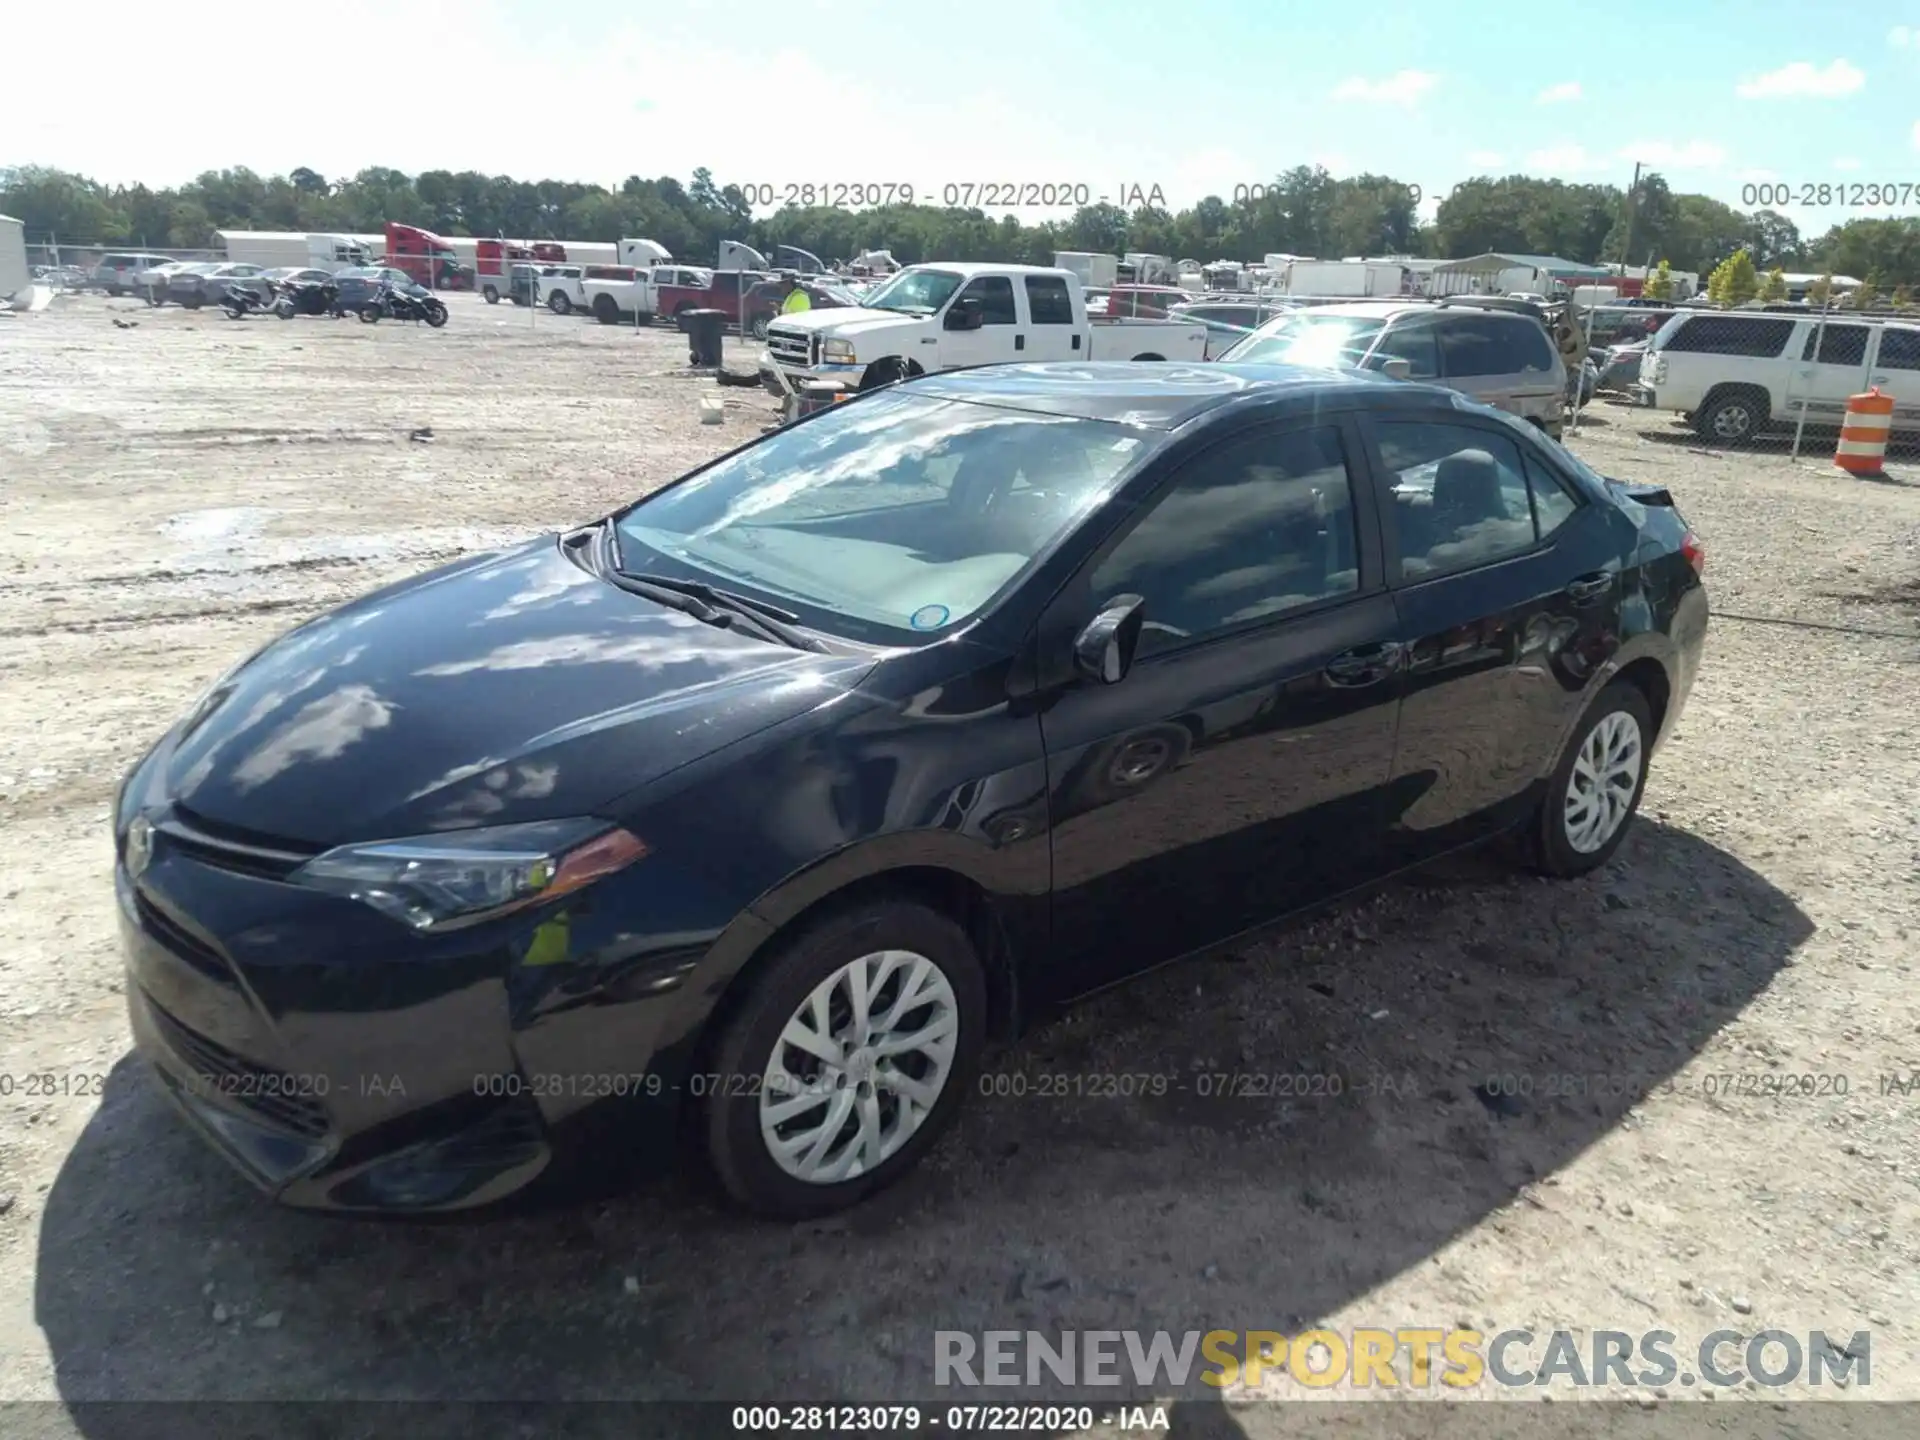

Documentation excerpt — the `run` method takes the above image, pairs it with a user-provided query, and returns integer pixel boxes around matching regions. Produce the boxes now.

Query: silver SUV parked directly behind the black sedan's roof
[1219,298,1567,440]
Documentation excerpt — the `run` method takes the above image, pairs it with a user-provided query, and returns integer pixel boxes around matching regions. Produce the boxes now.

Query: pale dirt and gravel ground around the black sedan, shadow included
[0,298,1920,1440]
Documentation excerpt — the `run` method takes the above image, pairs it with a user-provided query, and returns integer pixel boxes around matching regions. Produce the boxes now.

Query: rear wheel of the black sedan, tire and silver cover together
[1528,680,1653,879]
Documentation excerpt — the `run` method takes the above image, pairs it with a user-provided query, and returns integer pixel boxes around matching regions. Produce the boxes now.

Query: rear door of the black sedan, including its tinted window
[1365,413,1622,864]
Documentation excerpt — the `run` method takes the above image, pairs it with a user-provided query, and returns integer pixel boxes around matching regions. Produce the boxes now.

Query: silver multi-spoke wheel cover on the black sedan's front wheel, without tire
[760,950,960,1185]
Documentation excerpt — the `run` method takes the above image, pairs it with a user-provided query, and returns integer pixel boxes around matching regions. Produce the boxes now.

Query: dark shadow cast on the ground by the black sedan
[35,818,1812,1440]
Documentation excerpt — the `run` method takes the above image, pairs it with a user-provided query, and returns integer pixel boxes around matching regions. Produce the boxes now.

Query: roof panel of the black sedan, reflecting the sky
[906,361,1457,430]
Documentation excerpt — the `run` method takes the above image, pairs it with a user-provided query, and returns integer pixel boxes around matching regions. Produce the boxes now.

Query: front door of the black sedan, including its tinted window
[1039,417,1400,998]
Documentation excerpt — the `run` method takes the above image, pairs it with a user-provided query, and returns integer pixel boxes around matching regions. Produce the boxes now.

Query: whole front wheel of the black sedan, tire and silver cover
[699,897,987,1219]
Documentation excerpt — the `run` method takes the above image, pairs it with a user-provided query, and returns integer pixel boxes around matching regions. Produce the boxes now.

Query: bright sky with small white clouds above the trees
[0,0,1920,240]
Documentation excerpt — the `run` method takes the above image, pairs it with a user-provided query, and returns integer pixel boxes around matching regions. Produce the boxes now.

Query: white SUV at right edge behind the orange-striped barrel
[1632,311,1920,444]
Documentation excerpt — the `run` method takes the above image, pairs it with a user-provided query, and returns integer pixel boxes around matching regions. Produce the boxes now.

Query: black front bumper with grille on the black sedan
[115,806,697,1212]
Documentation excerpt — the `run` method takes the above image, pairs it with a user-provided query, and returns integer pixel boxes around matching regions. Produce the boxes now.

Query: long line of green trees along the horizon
[11,165,1920,286]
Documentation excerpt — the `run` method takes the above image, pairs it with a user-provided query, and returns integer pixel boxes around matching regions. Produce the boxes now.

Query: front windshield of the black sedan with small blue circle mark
[618,392,1148,645]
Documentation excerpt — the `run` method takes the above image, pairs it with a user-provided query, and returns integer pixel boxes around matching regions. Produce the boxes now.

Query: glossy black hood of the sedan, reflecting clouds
[165,536,874,847]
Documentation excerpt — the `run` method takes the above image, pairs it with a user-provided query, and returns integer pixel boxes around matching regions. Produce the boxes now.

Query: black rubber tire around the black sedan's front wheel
[697,897,987,1219]
